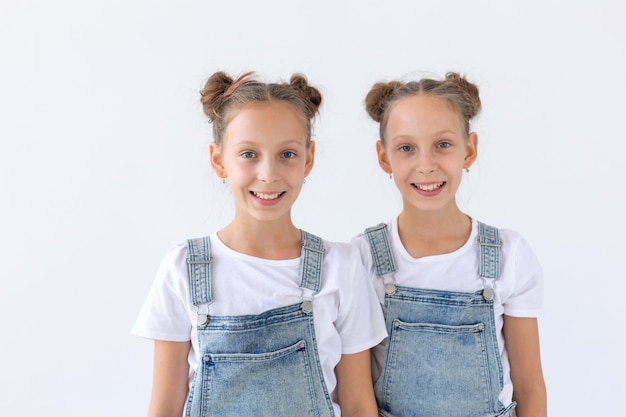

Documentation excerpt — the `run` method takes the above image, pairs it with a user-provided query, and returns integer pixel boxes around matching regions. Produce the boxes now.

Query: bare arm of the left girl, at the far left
[148,340,191,417]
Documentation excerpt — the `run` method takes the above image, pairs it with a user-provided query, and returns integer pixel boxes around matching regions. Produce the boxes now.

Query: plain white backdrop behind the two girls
[0,0,626,417]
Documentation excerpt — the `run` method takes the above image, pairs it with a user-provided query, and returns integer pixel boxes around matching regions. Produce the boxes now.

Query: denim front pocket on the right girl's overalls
[376,319,493,417]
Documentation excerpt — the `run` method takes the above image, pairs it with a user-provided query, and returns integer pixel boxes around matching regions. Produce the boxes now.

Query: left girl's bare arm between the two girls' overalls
[335,350,378,417]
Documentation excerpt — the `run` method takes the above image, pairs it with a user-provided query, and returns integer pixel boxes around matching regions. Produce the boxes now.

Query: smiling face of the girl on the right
[377,95,478,211]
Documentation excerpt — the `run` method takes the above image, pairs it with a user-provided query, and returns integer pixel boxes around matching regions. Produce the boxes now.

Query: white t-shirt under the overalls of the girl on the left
[132,233,387,415]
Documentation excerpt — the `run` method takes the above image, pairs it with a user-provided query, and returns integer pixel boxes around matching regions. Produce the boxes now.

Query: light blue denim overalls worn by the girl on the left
[185,231,334,417]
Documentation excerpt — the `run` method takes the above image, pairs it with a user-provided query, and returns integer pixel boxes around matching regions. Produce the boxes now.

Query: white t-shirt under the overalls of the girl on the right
[352,218,543,406]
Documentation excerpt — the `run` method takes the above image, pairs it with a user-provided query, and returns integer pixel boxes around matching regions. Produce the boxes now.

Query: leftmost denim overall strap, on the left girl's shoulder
[187,236,211,306]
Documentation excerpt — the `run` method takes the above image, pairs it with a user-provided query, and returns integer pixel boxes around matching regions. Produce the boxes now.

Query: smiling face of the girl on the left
[209,102,315,221]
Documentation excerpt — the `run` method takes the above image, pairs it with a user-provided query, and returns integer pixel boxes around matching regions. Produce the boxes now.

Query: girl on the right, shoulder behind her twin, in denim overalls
[353,73,546,417]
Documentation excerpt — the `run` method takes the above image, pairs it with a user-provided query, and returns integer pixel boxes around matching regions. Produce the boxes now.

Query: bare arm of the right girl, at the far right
[504,315,548,417]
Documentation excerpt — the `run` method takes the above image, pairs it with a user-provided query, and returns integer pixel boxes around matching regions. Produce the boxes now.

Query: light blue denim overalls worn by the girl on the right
[366,222,515,417]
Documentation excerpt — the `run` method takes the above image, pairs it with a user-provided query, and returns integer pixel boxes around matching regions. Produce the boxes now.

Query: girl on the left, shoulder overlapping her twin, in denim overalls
[133,72,386,417]
